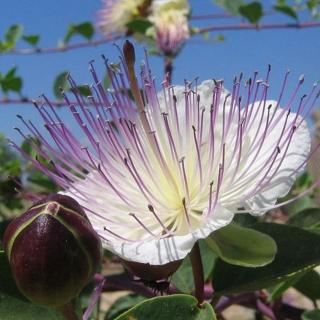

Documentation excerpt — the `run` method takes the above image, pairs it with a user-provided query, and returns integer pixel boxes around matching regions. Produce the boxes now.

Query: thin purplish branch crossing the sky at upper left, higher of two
[0,35,123,55]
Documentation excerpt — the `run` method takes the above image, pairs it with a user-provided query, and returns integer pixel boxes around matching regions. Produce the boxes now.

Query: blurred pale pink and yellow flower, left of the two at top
[97,0,148,36]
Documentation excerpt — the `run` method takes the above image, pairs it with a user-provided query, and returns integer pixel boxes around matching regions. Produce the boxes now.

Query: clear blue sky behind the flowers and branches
[0,0,320,139]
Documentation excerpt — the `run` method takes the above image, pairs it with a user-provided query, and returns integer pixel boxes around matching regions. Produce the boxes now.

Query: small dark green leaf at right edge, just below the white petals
[287,208,320,230]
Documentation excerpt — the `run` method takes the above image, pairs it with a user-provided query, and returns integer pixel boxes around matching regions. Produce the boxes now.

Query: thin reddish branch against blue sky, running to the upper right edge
[197,21,320,33]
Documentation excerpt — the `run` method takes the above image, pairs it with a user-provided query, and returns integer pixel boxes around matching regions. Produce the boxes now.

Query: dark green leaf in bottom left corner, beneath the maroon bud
[0,252,64,320]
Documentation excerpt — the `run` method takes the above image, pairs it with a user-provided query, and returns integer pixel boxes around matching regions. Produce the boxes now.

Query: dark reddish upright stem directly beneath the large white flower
[190,242,204,306]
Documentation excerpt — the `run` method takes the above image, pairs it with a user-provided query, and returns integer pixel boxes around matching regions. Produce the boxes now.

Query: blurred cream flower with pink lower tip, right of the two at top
[148,0,190,54]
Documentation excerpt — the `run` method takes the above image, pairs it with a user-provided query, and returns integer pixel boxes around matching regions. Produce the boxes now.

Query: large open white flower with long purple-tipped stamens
[13,42,319,265]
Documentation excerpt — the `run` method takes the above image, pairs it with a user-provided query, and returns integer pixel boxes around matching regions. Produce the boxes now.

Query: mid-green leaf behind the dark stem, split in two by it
[171,240,216,293]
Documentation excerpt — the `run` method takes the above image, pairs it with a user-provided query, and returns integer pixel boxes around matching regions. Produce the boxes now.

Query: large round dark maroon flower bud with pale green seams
[4,194,101,307]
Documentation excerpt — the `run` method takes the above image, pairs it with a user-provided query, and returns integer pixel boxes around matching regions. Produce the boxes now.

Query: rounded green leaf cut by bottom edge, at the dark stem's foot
[116,294,216,320]
